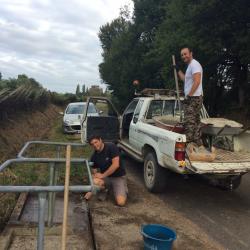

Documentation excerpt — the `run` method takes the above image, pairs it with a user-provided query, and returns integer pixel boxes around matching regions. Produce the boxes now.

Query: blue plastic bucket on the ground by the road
[141,224,176,250]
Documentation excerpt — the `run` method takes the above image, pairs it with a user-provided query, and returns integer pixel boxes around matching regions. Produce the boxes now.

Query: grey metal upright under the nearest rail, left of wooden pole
[37,192,47,250]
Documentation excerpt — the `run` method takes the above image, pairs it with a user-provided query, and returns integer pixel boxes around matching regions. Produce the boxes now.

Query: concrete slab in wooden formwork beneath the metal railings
[0,193,93,250]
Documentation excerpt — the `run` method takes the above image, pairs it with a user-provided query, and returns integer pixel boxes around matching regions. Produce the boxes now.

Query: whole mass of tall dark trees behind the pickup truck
[99,0,250,115]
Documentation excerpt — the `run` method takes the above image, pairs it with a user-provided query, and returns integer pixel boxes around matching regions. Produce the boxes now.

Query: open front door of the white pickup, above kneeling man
[81,97,120,143]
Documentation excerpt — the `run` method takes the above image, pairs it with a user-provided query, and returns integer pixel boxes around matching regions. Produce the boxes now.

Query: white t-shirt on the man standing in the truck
[184,59,203,96]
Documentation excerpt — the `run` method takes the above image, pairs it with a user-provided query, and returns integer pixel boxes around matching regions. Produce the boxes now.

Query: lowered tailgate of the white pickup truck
[188,149,250,174]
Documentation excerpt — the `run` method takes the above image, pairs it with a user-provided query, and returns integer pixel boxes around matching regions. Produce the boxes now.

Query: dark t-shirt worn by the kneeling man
[90,143,126,177]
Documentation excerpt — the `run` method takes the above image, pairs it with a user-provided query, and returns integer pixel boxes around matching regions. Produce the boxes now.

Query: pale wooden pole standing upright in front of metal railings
[62,145,71,250]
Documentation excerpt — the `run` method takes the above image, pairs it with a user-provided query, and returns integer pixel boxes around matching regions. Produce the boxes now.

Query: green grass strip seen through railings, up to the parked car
[0,114,92,185]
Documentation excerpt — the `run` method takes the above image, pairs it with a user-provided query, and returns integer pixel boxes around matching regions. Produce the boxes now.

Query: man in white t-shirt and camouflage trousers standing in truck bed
[177,47,203,146]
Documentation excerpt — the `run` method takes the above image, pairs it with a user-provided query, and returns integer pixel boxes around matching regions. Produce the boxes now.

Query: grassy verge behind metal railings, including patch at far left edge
[0,111,92,231]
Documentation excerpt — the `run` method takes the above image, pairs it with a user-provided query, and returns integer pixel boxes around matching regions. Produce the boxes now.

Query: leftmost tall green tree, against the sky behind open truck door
[99,11,136,108]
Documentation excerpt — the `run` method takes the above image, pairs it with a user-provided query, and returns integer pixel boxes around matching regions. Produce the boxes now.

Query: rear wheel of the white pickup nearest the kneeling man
[144,152,166,193]
